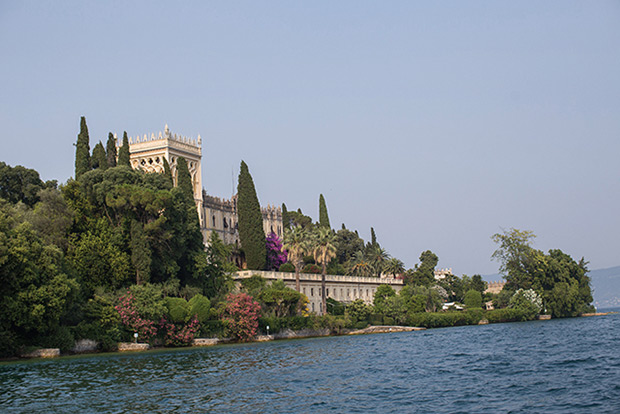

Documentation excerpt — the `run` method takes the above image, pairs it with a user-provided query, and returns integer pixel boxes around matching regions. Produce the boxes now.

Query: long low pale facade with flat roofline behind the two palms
[233,270,403,315]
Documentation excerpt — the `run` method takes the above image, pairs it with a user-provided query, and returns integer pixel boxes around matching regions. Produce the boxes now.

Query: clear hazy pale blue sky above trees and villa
[0,0,620,276]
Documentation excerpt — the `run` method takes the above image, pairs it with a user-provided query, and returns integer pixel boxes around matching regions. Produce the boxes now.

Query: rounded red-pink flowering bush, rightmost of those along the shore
[223,293,260,341]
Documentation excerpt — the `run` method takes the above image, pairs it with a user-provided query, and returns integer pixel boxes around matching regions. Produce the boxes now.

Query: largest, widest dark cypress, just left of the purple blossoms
[237,161,267,270]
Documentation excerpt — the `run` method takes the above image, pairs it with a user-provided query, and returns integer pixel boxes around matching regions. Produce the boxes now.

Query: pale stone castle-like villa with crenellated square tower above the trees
[123,125,283,249]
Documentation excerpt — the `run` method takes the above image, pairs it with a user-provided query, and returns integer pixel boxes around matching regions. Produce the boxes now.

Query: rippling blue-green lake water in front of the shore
[0,315,620,413]
